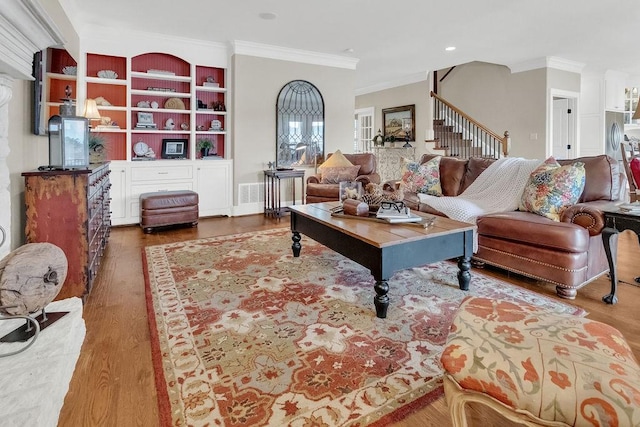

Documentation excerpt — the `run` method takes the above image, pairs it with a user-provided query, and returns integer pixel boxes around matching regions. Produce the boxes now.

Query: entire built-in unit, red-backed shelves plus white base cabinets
[78,52,233,225]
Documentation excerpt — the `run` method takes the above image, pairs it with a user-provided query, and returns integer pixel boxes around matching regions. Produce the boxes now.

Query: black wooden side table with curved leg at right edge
[602,207,640,304]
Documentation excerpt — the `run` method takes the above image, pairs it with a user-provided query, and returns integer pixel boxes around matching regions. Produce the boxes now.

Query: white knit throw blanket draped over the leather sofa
[418,157,542,253]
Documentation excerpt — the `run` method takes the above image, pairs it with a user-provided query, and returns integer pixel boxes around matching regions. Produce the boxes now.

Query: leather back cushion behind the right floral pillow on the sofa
[558,154,620,203]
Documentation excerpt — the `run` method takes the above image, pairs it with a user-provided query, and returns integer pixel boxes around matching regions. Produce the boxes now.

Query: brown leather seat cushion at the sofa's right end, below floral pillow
[477,211,589,253]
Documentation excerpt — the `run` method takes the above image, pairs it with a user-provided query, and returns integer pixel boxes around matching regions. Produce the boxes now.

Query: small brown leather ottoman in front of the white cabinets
[140,190,199,233]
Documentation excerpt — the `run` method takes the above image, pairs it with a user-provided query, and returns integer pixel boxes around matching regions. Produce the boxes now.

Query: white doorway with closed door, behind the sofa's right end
[550,92,578,159]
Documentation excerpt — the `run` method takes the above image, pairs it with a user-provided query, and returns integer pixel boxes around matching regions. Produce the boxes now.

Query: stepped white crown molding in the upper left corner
[0,0,64,80]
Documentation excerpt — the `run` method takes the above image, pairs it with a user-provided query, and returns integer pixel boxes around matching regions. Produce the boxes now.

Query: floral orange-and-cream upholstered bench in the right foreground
[441,297,640,426]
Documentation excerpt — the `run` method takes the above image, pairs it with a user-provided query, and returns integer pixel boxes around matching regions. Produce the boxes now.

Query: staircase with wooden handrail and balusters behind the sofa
[431,92,511,159]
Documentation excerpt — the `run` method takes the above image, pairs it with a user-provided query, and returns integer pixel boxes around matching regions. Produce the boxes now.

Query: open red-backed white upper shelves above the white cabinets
[84,53,228,161]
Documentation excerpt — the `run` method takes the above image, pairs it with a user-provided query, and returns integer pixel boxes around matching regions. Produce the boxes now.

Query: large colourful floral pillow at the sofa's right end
[519,157,585,221]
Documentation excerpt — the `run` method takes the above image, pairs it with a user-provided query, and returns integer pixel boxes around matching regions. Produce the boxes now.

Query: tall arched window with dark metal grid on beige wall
[276,80,324,167]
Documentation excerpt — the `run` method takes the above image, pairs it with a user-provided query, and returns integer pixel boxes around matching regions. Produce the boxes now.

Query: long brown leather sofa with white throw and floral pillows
[404,154,626,299]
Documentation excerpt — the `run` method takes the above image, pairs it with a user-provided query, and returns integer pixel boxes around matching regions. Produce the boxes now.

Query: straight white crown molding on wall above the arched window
[231,40,359,70]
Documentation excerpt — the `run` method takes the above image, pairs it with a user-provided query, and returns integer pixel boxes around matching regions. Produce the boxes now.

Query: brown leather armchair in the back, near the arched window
[306,153,380,203]
